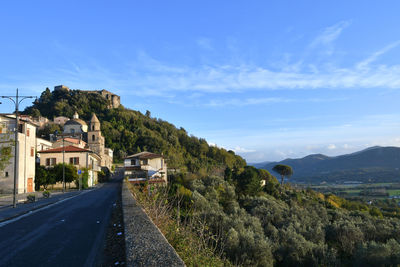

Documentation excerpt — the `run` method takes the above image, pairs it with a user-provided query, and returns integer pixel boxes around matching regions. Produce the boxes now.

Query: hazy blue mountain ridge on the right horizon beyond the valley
[253,146,400,186]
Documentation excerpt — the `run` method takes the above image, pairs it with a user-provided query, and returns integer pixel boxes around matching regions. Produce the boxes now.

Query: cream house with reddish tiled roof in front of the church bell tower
[38,146,101,186]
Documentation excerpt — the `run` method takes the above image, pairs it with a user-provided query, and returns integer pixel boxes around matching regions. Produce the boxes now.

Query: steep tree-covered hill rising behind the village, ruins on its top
[23,88,246,174]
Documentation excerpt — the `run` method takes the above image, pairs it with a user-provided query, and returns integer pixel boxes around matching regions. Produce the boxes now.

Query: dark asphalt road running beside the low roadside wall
[0,178,121,266]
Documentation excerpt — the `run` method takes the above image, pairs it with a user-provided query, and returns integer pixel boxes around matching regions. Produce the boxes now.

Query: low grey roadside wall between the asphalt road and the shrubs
[121,181,186,267]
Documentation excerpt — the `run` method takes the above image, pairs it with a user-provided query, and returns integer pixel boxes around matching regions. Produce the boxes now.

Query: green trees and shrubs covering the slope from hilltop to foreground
[25,90,400,266]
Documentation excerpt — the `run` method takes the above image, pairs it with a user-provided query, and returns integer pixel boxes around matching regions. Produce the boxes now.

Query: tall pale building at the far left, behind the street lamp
[0,114,37,194]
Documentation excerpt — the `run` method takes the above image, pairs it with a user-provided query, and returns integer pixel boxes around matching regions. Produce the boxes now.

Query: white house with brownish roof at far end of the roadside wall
[124,152,167,184]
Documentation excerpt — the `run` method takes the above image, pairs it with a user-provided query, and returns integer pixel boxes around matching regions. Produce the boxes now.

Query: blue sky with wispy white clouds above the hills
[0,0,400,162]
